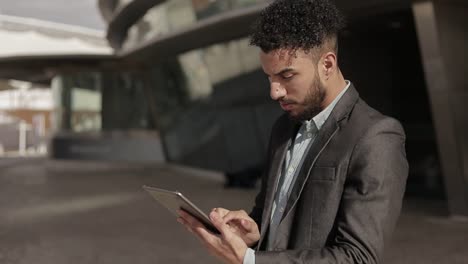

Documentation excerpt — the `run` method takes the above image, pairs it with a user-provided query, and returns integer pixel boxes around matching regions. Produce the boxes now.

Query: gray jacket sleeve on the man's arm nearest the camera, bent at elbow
[255,118,408,264]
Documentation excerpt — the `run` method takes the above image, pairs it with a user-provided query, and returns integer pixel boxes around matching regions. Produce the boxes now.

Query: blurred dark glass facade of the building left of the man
[53,0,281,173]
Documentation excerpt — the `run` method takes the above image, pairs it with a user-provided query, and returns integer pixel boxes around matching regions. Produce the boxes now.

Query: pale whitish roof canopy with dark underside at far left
[0,15,114,83]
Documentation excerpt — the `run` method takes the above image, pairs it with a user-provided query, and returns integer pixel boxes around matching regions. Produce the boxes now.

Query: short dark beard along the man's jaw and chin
[289,76,326,122]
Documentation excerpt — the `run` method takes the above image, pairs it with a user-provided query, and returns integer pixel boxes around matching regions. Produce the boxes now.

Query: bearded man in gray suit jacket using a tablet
[178,0,408,264]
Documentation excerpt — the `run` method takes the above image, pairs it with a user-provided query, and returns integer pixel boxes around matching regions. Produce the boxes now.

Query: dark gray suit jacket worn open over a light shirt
[251,85,408,264]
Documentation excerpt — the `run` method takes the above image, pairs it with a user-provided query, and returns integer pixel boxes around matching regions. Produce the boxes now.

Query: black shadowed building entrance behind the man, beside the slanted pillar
[339,9,445,198]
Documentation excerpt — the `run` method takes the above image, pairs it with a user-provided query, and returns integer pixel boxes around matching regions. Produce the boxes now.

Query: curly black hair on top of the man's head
[250,0,345,53]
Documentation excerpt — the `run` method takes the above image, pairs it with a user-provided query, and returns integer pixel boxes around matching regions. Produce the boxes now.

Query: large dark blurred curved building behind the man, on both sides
[0,0,468,218]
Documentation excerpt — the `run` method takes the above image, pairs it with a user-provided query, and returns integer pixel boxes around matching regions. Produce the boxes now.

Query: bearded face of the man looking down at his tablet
[260,49,326,121]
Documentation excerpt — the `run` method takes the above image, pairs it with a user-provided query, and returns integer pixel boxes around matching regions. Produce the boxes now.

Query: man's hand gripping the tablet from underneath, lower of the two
[177,210,247,264]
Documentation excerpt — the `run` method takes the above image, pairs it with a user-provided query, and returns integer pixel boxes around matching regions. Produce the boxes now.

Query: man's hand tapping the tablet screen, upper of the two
[212,208,260,247]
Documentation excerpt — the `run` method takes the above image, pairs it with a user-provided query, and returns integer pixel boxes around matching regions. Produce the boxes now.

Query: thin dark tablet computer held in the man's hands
[143,185,219,234]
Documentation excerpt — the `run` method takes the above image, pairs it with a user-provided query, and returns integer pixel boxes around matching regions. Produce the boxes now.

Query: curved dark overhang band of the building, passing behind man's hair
[99,0,411,61]
